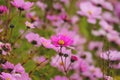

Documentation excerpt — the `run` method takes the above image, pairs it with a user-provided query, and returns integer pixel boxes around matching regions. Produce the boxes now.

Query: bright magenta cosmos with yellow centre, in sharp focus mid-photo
[51,34,73,47]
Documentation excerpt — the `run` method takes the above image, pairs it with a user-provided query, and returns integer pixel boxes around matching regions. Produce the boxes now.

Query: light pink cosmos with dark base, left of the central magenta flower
[25,32,41,46]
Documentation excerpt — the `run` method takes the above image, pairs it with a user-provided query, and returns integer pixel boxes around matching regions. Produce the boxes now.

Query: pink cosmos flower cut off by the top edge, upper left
[11,0,34,11]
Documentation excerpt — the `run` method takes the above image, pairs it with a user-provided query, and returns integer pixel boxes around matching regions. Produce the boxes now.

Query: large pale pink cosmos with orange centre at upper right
[78,2,102,24]
